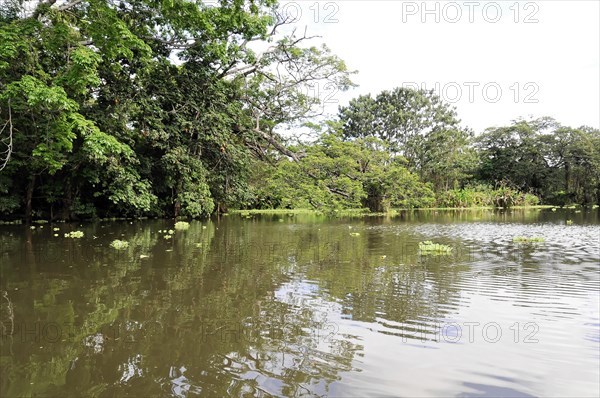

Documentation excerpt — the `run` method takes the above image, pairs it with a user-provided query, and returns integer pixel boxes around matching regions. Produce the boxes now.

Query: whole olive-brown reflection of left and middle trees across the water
[0,211,596,396]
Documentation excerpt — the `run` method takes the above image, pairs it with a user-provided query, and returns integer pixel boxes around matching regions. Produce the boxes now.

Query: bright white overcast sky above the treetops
[281,0,600,133]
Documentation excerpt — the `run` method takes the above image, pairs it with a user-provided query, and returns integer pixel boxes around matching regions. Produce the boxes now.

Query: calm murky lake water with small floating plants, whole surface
[0,209,600,397]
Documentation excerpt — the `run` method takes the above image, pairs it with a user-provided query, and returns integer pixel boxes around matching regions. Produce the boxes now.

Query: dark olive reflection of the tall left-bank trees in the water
[2,221,356,396]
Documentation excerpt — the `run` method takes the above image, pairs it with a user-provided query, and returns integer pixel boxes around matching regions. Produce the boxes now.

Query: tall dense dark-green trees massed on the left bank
[0,0,351,218]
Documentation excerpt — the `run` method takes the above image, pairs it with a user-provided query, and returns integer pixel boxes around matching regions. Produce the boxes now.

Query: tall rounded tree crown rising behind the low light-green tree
[339,87,471,187]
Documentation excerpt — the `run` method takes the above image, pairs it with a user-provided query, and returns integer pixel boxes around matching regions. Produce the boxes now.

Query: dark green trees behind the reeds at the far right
[477,117,600,204]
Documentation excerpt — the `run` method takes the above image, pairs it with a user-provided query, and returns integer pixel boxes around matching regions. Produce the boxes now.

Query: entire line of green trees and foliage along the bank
[0,0,600,220]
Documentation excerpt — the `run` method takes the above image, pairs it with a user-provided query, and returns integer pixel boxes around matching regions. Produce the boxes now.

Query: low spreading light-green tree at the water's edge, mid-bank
[271,122,434,212]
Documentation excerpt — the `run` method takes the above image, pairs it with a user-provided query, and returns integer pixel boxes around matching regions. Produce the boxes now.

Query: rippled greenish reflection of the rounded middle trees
[290,222,466,337]
